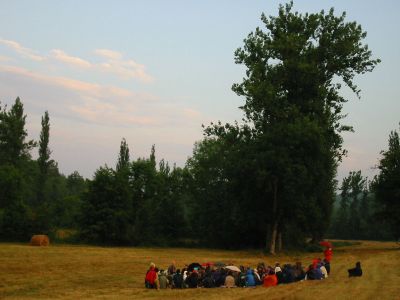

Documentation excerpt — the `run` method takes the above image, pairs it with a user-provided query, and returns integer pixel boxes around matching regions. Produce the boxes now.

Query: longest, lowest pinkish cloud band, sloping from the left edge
[0,65,202,131]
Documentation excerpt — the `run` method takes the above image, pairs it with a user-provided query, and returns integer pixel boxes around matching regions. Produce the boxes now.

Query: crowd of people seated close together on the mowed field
[145,259,330,289]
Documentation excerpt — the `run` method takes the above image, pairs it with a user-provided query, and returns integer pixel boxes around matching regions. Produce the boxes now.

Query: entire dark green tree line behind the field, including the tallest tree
[0,2,400,253]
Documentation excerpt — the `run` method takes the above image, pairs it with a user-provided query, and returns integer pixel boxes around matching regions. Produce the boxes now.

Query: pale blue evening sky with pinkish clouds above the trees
[0,0,400,181]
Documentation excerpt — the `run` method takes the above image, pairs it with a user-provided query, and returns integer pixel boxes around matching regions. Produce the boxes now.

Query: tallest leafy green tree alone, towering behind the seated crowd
[203,2,379,253]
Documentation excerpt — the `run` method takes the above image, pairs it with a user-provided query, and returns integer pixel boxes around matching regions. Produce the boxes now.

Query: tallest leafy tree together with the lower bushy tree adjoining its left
[189,2,379,253]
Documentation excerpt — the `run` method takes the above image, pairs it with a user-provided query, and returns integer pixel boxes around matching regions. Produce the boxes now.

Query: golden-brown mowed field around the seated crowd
[0,241,400,300]
